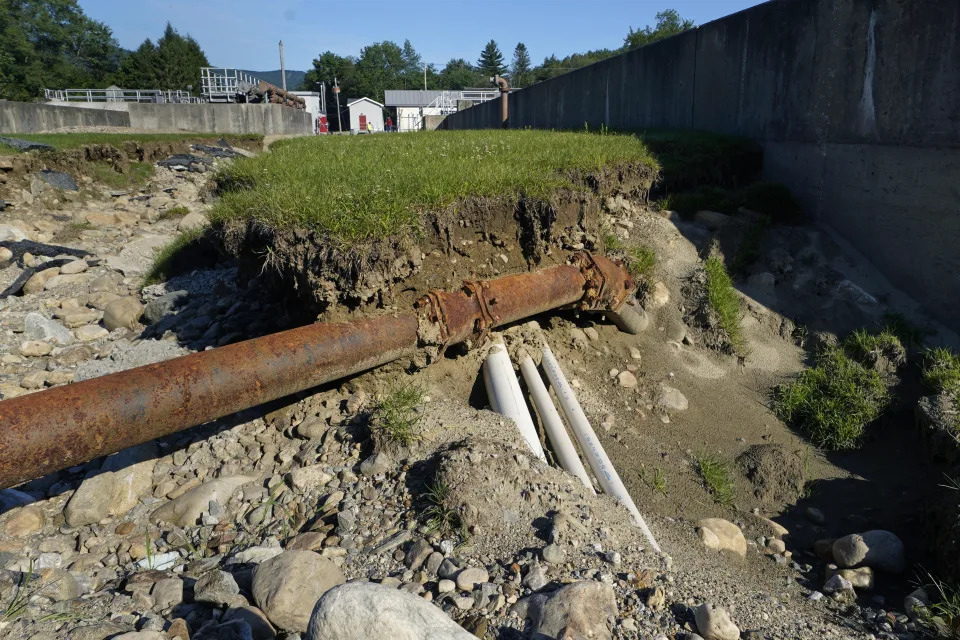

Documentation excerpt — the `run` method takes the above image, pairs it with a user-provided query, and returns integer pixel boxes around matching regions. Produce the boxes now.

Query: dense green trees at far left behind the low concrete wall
[0,0,209,100]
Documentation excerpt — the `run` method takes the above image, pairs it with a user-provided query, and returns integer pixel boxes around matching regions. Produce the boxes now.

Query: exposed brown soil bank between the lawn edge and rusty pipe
[218,166,655,319]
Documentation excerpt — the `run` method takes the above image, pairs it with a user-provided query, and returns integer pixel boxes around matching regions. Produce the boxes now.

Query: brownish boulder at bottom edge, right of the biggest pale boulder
[514,582,617,640]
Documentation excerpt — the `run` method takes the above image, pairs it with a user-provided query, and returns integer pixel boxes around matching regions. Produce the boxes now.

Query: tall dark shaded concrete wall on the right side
[443,0,960,328]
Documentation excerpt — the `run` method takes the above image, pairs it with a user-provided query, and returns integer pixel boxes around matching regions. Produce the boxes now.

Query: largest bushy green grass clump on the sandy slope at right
[773,332,902,450]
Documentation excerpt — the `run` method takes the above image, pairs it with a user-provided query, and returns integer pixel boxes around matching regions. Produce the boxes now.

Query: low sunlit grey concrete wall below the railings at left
[0,102,313,135]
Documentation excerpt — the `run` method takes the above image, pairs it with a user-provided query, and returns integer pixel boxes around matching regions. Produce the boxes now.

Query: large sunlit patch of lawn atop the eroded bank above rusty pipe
[211,131,658,242]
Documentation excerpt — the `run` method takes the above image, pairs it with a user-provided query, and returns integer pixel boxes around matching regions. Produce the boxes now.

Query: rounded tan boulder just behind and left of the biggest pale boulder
[253,551,345,637]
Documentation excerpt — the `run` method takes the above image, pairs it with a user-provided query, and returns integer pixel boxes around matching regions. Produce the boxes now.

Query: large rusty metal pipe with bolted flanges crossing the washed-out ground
[0,254,632,488]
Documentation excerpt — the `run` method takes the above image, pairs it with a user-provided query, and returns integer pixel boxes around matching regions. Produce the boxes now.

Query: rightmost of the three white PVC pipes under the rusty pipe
[543,346,661,553]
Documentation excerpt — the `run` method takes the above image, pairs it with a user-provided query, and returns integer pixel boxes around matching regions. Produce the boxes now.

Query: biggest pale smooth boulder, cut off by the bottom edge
[304,582,474,640]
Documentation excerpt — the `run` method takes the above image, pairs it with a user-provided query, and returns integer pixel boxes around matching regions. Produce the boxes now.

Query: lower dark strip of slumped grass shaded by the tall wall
[655,182,804,224]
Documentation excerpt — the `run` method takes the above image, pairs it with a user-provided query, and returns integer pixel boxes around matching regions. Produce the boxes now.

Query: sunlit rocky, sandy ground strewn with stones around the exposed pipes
[0,145,950,640]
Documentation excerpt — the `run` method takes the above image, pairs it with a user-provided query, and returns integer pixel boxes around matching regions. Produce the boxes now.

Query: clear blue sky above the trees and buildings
[79,0,761,71]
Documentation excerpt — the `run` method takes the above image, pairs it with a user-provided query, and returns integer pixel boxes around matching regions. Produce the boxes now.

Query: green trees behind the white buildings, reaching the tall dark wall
[300,9,695,102]
